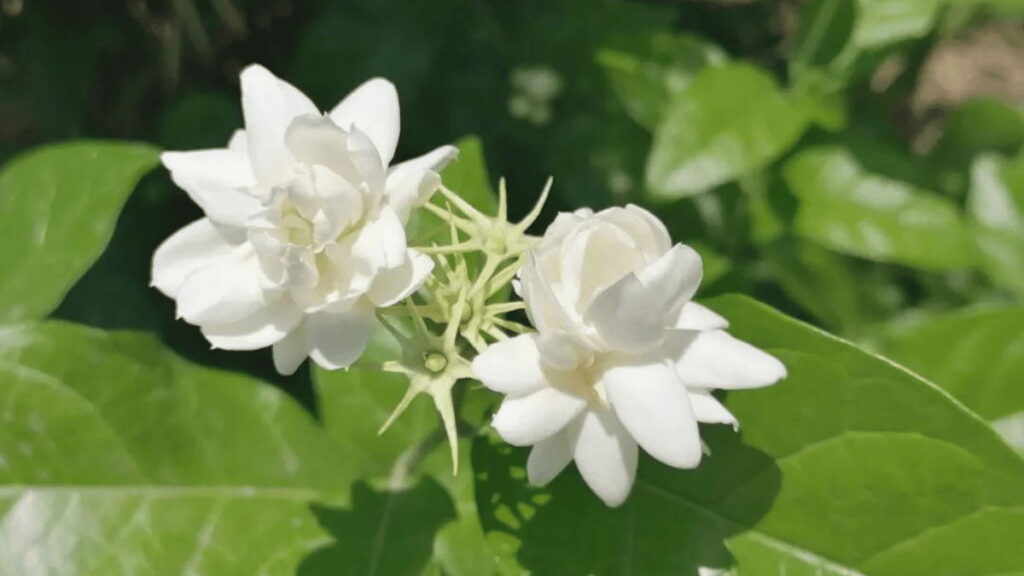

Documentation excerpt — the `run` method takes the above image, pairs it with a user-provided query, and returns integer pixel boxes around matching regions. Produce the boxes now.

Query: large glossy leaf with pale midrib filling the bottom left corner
[0,322,347,576]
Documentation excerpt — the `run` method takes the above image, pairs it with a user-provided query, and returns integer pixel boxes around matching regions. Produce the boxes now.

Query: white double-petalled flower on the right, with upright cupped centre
[472,206,785,506]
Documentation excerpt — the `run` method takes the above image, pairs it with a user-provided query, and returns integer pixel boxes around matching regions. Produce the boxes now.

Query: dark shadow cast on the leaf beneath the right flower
[473,420,780,576]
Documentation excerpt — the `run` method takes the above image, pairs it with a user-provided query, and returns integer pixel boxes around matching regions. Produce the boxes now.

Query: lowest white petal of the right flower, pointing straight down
[572,410,637,506]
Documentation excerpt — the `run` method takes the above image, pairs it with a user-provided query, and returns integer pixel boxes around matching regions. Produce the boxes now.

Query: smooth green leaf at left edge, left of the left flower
[0,141,158,322]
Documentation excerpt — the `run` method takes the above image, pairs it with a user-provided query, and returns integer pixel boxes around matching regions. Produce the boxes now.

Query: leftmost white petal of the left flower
[153,218,238,298]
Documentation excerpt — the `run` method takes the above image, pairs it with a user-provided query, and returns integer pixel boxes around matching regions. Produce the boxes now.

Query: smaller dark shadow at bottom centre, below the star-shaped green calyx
[296,479,455,576]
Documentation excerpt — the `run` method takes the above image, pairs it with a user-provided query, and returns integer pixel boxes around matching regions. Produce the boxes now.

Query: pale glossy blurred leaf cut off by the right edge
[968,155,1024,295]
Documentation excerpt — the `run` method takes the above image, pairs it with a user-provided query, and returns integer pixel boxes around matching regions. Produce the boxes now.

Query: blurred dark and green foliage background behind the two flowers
[0,0,1024,414]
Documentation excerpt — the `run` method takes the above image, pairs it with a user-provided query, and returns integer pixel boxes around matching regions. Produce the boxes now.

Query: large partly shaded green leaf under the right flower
[473,296,1024,576]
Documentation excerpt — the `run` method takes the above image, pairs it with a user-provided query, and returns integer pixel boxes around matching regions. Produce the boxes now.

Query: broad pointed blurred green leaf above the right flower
[647,64,807,199]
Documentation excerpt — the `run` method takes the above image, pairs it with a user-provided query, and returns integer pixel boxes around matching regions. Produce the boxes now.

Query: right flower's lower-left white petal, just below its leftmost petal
[490,386,587,446]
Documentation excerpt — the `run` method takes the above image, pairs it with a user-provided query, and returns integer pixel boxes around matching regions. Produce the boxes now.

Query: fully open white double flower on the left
[153,66,458,373]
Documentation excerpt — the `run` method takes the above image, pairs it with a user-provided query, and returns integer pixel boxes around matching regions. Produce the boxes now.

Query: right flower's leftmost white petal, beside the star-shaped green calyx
[473,334,545,395]
